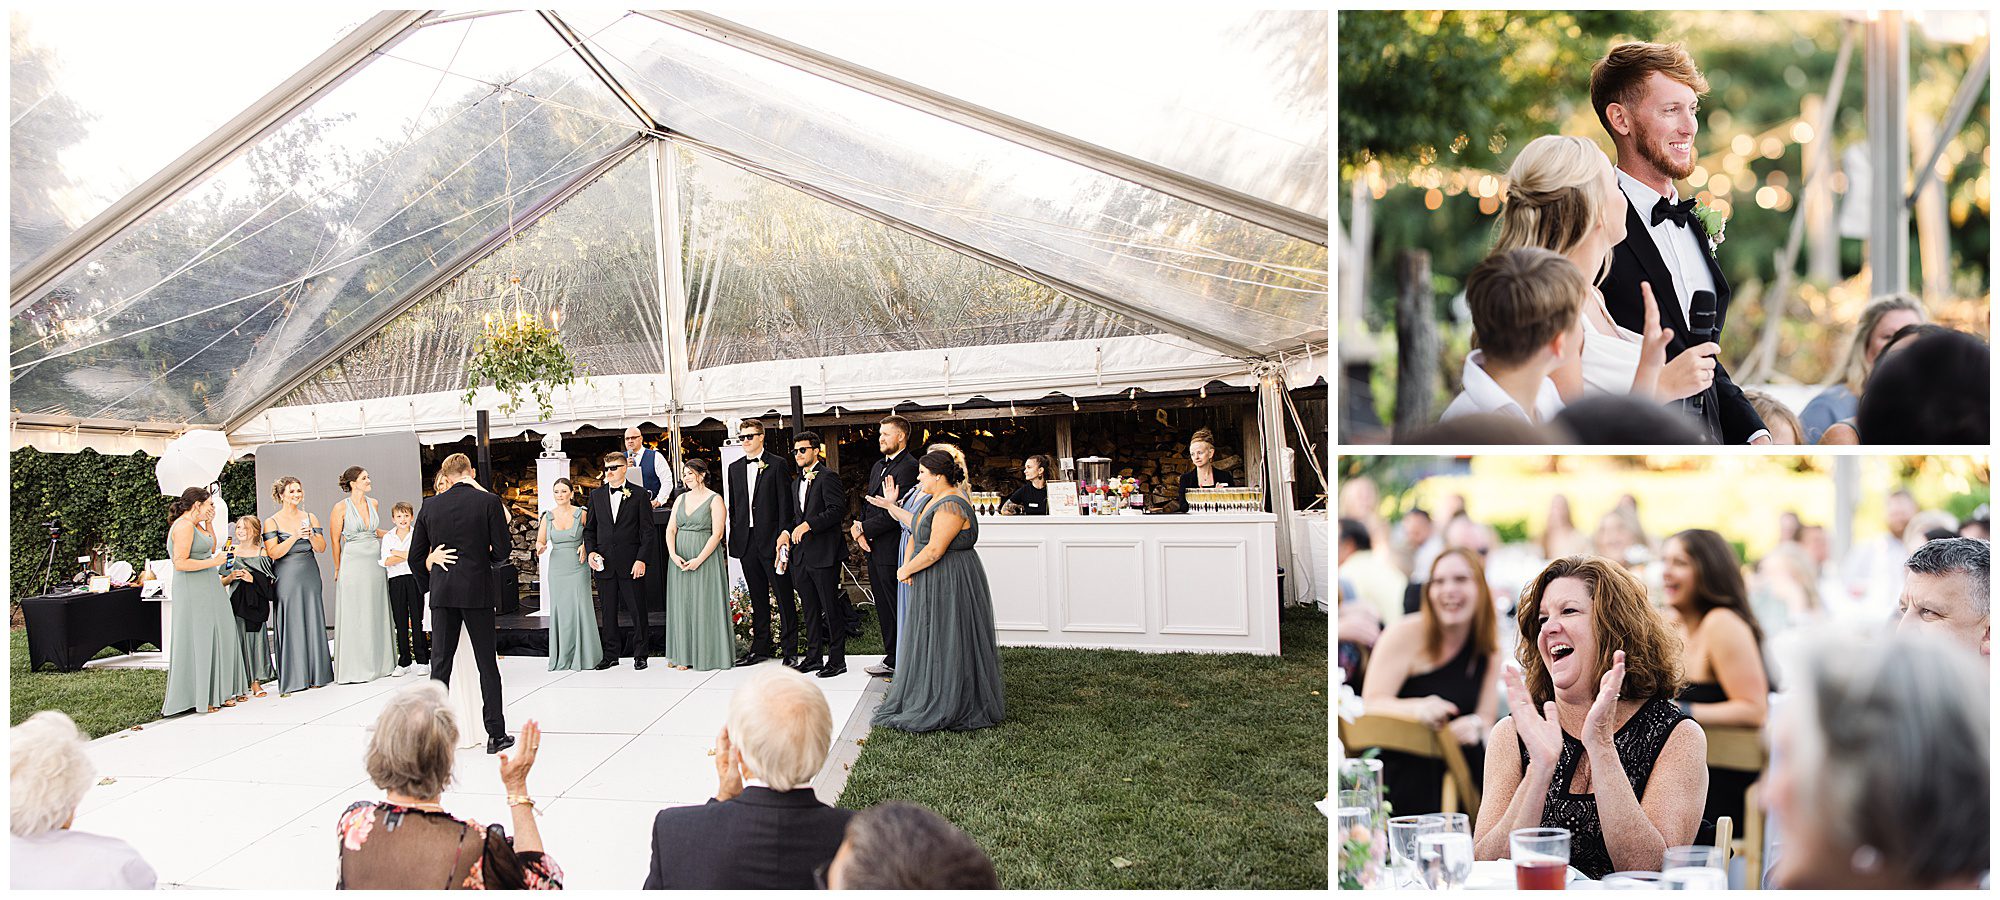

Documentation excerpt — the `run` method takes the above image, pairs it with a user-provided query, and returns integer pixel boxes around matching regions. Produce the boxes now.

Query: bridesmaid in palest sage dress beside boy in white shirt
[334,466,396,684]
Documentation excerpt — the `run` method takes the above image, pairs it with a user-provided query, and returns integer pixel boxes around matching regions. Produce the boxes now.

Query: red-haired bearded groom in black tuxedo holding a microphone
[1590,42,1770,444]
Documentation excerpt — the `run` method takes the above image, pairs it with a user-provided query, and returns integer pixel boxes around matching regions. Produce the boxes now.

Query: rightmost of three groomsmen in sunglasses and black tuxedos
[778,432,848,678]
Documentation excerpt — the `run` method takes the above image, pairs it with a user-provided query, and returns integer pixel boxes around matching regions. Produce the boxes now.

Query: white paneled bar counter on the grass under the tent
[978,512,1278,656]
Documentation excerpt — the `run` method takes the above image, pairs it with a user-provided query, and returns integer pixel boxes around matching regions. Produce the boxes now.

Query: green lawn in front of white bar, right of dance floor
[840,608,1328,890]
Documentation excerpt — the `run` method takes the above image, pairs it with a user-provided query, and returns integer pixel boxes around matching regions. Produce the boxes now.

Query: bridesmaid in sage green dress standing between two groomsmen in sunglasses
[666,460,736,672]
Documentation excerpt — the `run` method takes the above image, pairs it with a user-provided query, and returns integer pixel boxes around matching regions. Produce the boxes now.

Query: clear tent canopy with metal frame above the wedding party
[10,10,1328,440]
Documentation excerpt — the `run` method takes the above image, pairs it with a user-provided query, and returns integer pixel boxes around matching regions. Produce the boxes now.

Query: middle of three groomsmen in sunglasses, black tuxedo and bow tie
[728,418,798,666]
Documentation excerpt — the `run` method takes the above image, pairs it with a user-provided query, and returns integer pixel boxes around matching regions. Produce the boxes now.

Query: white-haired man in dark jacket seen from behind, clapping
[646,664,854,890]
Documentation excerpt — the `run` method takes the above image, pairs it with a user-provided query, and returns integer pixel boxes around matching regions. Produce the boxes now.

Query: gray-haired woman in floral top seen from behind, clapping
[336,680,562,890]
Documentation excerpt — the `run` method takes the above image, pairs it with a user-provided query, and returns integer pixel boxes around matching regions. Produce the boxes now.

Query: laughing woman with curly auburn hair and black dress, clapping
[1472,556,1708,878]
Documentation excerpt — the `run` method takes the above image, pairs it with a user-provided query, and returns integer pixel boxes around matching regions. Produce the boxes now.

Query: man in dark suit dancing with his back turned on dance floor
[410,454,514,754]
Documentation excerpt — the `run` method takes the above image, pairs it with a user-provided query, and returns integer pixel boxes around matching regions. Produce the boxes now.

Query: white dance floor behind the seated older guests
[74,656,882,890]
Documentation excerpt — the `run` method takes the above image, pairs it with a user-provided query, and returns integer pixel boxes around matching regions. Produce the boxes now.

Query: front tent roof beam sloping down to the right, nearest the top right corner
[638,10,1326,246]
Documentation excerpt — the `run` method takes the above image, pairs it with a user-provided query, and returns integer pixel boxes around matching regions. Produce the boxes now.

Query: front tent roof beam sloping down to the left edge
[8,10,426,316]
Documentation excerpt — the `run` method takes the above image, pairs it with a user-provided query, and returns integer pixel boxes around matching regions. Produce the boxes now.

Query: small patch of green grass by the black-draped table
[8,628,166,738]
